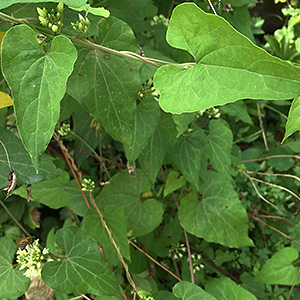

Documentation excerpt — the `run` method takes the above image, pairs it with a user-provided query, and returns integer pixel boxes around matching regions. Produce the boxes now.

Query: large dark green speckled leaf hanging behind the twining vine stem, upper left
[68,18,140,144]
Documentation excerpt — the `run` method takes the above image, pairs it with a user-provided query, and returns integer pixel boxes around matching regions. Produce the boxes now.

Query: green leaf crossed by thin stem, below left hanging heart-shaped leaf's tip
[14,171,69,209]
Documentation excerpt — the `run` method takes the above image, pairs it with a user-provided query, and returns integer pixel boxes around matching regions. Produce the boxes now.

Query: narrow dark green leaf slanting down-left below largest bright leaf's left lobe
[139,112,177,182]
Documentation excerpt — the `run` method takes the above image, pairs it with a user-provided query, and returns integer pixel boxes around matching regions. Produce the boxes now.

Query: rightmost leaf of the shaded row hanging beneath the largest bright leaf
[205,119,233,173]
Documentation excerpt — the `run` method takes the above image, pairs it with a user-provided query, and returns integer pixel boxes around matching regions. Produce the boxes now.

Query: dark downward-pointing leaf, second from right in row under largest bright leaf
[169,128,205,189]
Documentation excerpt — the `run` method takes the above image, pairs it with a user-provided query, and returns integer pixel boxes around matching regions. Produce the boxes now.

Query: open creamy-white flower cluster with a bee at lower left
[17,239,51,278]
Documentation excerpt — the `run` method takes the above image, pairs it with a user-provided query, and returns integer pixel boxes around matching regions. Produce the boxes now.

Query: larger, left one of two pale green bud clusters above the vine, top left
[37,2,64,33]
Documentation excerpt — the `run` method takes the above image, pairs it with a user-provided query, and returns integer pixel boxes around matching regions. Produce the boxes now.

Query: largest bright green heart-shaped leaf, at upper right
[154,3,300,114]
